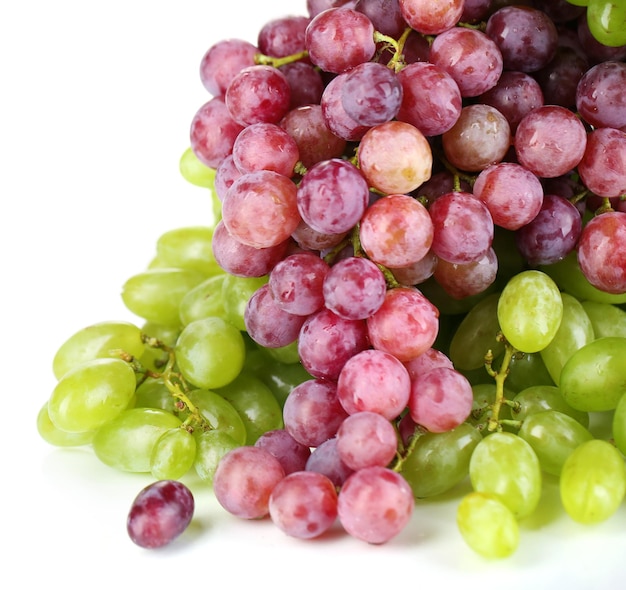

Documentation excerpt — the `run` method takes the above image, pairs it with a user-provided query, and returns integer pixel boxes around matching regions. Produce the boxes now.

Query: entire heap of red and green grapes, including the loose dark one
[38,0,626,558]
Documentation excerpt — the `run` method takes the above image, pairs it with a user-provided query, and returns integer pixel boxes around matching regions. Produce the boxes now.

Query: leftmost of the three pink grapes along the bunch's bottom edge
[213,446,285,519]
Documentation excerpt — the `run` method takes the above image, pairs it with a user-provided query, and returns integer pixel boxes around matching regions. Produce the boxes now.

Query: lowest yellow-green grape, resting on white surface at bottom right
[456,492,520,559]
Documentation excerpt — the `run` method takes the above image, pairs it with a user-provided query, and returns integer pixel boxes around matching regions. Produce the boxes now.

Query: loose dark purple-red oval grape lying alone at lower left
[126,480,195,549]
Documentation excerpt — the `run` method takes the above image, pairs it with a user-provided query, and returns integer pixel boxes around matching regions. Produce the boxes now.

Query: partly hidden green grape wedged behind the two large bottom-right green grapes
[519,410,593,476]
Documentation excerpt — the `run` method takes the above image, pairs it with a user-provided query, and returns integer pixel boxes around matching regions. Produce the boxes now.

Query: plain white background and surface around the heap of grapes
[0,0,626,590]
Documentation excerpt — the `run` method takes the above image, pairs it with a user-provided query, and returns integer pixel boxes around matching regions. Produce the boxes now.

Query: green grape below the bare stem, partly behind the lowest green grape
[469,432,542,518]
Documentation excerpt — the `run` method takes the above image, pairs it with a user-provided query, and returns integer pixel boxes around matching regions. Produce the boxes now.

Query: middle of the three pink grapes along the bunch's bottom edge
[269,471,338,539]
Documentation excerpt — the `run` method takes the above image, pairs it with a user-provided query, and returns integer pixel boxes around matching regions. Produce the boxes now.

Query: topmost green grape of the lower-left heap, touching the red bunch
[155,225,224,277]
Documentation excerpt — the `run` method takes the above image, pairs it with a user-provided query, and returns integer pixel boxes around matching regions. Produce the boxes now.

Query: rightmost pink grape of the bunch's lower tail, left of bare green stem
[408,367,474,432]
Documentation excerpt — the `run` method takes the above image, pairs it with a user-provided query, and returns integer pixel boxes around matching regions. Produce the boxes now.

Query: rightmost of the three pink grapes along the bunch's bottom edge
[337,466,414,544]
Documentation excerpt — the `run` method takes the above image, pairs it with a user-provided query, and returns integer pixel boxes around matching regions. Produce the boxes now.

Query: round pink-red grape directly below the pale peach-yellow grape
[359,194,434,268]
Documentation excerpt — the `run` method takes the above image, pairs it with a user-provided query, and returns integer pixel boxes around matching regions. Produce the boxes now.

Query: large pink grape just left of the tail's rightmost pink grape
[337,349,411,420]
